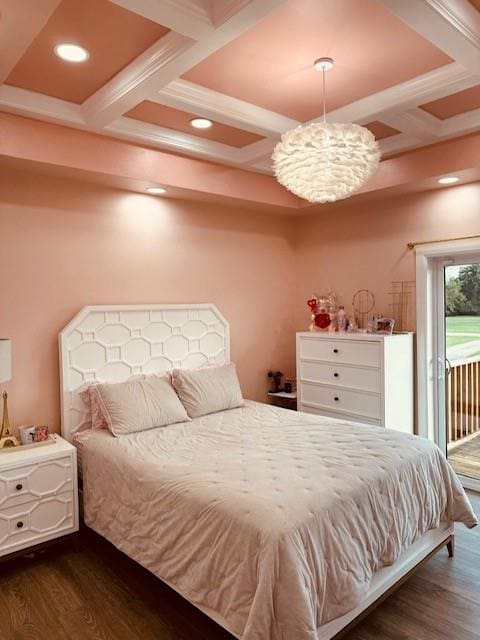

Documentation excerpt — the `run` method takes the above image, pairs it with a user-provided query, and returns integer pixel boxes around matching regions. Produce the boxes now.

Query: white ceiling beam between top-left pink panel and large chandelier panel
[83,0,286,129]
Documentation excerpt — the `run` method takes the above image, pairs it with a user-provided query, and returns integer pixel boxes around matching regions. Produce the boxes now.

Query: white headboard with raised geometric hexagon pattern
[59,304,230,440]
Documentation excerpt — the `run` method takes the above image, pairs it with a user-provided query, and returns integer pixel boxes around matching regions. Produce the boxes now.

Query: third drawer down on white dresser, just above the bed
[300,382,381,419]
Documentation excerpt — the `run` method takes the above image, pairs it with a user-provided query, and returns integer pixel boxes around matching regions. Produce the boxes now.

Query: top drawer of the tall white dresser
[299,338,381,367]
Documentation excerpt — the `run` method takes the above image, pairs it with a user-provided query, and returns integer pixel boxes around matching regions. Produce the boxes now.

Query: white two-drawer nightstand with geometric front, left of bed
[0,436,78,557]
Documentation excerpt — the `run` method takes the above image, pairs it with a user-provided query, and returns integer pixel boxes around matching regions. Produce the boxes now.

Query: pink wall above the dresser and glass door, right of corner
[295,183,480,329]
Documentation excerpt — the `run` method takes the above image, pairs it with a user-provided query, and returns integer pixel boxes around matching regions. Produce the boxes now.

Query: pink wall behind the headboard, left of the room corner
[0,170,294,429]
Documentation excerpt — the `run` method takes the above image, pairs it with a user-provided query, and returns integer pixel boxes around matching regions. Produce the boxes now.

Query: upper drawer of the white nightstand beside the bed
[0,454,75,513]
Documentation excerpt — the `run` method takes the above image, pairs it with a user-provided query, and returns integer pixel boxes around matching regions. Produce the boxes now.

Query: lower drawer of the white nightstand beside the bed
[0,491,77,556]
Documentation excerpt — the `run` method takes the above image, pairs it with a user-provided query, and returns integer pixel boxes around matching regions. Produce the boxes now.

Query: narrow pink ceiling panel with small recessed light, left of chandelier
[125,100,262,147]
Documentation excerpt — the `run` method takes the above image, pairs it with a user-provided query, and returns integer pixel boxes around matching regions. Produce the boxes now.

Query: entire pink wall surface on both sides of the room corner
[0,161,480,436]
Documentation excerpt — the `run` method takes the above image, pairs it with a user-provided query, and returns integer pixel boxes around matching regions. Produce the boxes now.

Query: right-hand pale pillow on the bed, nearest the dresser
[172,362,244,418]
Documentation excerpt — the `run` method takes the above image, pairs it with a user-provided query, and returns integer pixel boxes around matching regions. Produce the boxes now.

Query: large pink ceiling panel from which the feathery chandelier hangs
[183,0,451,122]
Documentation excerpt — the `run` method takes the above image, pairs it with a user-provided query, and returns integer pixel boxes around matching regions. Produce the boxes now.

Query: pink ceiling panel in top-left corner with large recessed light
[6,0,168,103]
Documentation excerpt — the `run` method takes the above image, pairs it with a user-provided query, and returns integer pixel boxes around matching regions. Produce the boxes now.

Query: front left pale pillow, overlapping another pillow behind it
[91,375,190,436]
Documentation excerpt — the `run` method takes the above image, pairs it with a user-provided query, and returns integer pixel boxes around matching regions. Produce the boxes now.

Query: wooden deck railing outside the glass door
[447,358,480,446]
